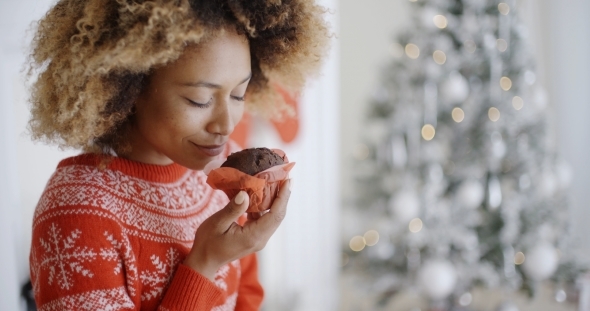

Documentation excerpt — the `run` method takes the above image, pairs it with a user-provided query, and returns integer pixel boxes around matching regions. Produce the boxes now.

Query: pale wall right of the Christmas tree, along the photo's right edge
[527,0,590,257]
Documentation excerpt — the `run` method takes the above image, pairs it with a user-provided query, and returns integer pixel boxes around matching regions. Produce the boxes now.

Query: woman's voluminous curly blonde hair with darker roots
[29,0,329,152]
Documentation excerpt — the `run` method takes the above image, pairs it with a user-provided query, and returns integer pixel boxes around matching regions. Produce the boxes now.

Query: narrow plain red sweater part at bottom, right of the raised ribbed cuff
[235,253,264,311]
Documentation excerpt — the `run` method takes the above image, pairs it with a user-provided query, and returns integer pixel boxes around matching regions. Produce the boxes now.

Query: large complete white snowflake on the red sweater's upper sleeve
[40,223,97,290]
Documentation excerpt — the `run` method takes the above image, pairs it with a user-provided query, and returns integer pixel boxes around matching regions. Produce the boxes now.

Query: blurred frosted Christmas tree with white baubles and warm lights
[344,0,579,309]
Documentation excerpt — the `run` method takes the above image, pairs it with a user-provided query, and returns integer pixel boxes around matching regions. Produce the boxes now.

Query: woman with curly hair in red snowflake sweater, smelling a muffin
[30,0,327,310]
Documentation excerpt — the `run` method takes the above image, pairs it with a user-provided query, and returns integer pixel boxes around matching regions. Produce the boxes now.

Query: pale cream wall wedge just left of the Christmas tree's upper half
[338,0,409,204]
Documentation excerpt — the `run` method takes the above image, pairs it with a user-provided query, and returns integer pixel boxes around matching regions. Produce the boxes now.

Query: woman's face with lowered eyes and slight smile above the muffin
[124,30,252,170]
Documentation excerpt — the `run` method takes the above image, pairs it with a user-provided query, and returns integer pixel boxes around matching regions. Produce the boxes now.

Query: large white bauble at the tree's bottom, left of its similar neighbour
[418,260,457,300]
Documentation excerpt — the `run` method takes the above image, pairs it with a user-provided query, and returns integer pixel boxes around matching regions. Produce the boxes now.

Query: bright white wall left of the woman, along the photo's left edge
[0,0,77,310]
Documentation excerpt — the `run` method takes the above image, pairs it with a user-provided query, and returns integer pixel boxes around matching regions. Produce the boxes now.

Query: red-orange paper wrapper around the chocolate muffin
[205,149,295,213]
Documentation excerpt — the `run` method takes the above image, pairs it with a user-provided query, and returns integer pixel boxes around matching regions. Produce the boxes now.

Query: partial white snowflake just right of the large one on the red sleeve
[100,231,137,296]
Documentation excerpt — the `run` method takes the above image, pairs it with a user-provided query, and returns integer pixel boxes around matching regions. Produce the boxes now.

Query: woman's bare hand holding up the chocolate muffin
[184,180,291,281]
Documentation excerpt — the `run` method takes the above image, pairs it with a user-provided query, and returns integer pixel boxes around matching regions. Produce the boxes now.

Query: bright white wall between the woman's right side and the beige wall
[252,0,340,311]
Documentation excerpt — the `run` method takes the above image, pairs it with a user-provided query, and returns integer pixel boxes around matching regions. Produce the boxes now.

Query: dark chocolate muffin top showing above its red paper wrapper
[221,148,285,176]
